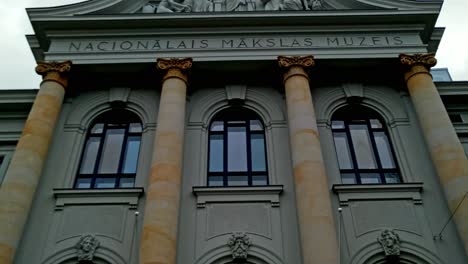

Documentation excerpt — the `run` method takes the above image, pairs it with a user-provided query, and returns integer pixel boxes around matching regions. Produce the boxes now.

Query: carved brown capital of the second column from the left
[156,58,193,84]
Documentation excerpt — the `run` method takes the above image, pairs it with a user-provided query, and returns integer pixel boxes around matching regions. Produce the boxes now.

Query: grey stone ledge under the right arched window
[332,182,423,206]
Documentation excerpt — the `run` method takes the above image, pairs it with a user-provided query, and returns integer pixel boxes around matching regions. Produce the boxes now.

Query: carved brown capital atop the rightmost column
[400,53,437,81]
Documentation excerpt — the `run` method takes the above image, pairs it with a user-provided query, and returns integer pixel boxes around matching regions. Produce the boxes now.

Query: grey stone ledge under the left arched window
[53,188,144,211]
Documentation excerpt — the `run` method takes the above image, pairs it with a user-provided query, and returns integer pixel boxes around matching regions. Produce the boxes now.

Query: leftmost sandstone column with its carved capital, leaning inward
[0,61,71,264]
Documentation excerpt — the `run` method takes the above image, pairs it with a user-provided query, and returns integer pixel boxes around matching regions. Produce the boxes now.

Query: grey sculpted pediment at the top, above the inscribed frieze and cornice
[28,0,443,18]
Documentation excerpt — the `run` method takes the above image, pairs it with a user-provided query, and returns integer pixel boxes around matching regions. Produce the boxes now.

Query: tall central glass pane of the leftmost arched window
[99,129,125,173]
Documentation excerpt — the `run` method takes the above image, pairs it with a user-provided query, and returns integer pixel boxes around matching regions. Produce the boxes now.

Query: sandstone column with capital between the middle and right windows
[278,56,338,264]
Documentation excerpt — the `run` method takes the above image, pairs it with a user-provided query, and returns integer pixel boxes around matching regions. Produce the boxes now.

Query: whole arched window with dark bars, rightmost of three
[332,106,401,184]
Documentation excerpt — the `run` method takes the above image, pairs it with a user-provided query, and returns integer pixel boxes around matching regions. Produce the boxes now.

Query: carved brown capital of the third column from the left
[278,55,315,82]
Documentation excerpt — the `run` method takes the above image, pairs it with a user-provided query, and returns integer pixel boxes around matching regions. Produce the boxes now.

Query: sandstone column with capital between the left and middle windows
[140,58,192,264]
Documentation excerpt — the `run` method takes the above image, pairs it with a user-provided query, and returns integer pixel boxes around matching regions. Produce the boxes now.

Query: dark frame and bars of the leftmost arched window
[73,110,143,189]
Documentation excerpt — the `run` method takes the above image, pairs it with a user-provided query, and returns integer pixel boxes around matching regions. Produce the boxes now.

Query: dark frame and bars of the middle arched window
[206,108,270,187]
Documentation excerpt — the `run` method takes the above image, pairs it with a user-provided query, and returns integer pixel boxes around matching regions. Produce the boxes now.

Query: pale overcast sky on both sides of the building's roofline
[0,0,468,89]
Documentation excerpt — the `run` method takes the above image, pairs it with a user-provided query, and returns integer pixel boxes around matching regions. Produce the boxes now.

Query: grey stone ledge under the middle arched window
[192,185,283,208]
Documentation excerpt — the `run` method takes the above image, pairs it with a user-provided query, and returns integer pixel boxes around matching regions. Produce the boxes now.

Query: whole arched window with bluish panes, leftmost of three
[75,110,142,189]
